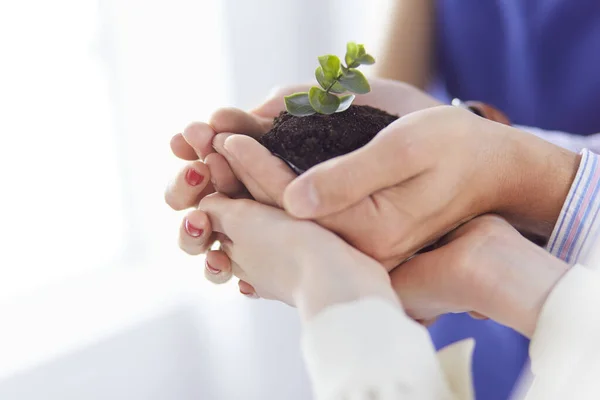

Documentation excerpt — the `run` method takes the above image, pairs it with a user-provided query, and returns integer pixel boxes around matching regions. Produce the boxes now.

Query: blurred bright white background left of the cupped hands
[0,0,391,399]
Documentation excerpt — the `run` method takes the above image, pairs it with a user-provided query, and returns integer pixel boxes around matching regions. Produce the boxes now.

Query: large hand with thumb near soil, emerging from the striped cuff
[282,107,580,261]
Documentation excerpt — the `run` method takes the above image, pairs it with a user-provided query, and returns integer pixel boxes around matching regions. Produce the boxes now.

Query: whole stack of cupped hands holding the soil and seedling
[165,79,580,336]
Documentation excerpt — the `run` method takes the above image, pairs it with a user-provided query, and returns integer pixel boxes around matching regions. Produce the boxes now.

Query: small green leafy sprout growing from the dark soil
[285,42,375,117]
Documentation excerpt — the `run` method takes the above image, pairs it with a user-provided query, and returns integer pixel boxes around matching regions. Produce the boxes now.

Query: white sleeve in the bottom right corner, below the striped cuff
[526,265,600,400]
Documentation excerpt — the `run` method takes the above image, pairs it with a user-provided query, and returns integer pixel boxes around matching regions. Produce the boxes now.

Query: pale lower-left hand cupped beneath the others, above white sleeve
[191,194,398,318]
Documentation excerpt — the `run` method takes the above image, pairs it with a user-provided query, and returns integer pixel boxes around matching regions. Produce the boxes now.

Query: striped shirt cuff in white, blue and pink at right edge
[547,149,600,265]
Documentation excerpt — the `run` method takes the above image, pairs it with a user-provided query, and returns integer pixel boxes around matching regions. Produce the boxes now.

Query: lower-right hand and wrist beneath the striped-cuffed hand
[390,215,568,337]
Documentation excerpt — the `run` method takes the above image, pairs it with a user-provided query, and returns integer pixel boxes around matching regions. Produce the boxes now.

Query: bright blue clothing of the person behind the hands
[430,0,600,400]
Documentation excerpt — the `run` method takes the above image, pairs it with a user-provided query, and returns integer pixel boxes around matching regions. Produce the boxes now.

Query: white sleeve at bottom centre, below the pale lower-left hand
[302,298,473,400]
